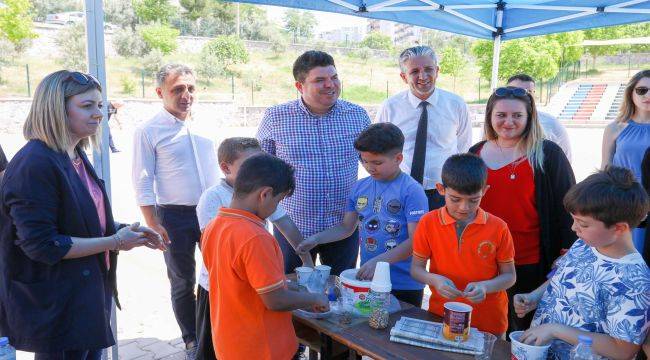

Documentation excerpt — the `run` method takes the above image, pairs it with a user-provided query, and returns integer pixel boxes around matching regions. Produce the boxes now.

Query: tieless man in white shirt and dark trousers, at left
[132,64,218,360]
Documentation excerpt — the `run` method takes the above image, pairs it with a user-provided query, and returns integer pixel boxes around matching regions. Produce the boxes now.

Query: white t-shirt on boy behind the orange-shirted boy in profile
[196,179,287,291]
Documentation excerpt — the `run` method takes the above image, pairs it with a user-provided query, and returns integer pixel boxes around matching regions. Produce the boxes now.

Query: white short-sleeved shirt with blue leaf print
[532,239,650,360]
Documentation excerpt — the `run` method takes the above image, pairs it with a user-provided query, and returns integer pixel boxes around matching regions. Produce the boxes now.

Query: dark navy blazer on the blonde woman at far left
[0,140,117,352]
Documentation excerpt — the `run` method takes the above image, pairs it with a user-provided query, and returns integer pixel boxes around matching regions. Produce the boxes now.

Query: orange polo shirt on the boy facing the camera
[413,207,514,334]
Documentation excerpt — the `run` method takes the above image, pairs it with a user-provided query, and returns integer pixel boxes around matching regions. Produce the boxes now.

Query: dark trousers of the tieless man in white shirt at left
[156,205,201,345]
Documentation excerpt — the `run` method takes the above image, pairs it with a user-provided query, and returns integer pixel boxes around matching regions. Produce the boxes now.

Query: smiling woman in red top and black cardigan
[470,86,576,331]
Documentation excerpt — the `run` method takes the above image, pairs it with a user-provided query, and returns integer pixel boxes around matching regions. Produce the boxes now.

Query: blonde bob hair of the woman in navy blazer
[23,70,102,152]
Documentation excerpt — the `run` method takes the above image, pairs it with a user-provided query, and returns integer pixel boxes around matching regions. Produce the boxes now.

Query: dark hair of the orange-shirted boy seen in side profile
[234,153,296,198]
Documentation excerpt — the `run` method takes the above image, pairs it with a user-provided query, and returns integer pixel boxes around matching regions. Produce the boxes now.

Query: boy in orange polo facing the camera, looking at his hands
[411,154,516,336]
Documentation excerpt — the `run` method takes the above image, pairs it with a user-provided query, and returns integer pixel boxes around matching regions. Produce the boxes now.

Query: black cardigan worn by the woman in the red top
[469,140,577,273]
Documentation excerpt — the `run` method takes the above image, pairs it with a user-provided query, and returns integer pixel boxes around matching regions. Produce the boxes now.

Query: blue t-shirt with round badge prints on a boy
[346,173,429,290]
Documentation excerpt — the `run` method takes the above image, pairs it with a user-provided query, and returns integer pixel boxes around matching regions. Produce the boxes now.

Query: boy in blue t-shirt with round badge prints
[296,123,429,307]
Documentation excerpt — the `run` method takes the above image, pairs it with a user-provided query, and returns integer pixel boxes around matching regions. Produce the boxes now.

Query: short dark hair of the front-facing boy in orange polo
[442,153,487,195]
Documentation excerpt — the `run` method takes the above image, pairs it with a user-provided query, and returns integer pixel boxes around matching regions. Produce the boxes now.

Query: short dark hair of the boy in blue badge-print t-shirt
[354,123,404,155]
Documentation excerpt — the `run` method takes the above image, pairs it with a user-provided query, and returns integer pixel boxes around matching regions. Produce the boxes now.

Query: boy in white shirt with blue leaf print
[514,166,650,359]
